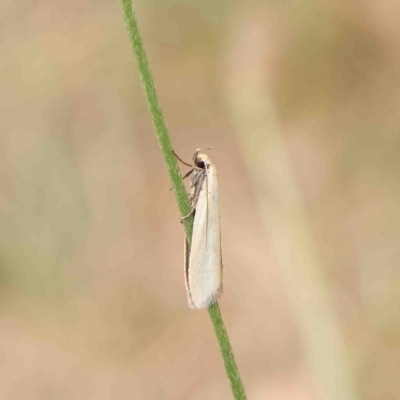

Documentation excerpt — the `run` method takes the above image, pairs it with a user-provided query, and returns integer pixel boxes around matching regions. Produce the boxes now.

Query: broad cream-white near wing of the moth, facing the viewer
[187,163,222,309]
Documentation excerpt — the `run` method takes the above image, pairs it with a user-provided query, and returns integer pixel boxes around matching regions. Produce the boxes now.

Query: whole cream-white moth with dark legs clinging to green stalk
[174,149,222,310]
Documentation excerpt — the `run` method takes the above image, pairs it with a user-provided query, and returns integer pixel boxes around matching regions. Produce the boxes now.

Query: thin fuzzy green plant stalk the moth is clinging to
[120,0,246,400]
